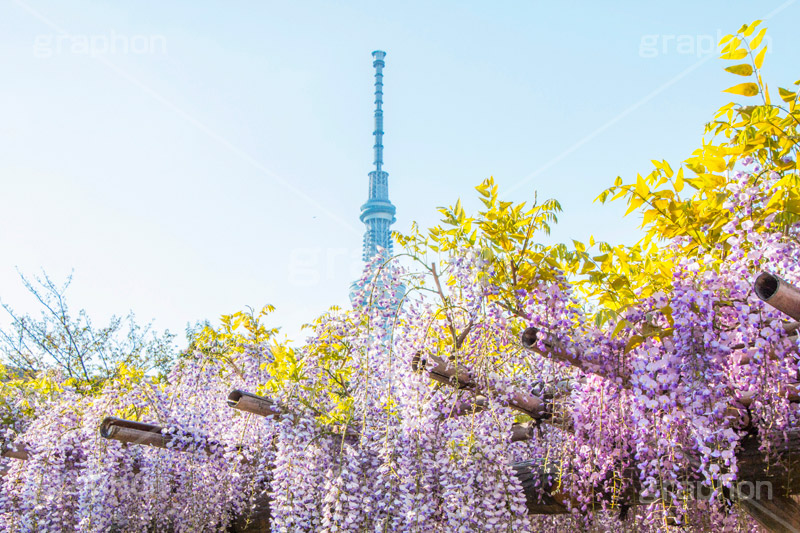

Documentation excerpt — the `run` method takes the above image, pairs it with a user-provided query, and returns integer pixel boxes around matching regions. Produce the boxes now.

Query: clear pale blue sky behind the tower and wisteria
[0,0,800,340]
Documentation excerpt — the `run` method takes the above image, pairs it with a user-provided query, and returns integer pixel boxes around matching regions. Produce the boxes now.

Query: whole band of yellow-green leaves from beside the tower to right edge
[397,21,800,324]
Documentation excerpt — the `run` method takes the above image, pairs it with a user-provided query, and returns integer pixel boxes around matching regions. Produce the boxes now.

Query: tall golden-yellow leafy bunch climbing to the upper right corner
[581,20,800,318]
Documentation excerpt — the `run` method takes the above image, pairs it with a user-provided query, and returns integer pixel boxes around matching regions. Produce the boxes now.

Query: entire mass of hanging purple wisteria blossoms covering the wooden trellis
[0,167,800,532]
